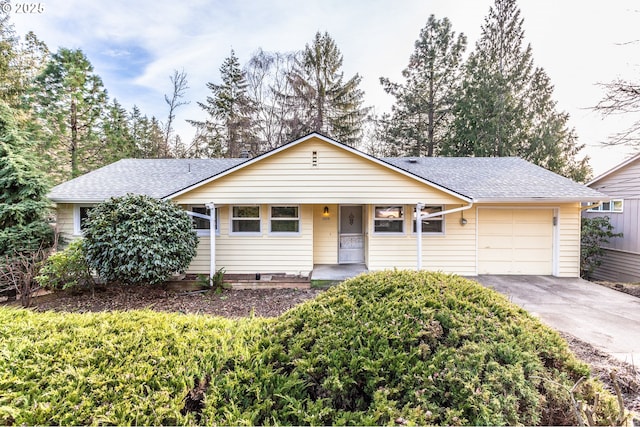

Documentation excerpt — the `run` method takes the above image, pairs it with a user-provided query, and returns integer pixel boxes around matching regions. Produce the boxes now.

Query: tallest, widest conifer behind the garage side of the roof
[442,0,590,181]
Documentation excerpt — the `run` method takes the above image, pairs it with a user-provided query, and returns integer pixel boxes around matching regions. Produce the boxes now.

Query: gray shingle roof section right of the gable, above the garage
[381,157,607,202]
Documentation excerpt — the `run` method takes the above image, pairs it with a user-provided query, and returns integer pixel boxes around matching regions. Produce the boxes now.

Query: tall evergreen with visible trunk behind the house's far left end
[36,48,107,181]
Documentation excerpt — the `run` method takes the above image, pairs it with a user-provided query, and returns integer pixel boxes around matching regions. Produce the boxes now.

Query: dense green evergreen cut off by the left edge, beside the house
[0,101,53,256]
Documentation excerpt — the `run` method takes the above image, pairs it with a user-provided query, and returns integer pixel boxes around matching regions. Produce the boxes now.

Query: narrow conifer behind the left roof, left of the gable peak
[189,50,256,157]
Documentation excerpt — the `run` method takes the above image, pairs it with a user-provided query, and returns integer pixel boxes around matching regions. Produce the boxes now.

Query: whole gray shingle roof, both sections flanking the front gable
[49,157,608,203]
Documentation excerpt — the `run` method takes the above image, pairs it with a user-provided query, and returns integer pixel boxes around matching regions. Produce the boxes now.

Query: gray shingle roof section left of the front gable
[49,159,247,202]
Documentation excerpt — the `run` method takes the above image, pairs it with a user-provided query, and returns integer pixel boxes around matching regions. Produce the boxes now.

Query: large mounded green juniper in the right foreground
[202,271,615,425]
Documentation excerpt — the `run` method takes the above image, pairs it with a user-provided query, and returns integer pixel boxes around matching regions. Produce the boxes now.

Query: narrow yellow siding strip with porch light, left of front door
[313,204,338,264]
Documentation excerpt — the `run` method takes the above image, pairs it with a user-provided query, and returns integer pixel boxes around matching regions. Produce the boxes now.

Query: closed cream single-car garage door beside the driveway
[478,208,553,275]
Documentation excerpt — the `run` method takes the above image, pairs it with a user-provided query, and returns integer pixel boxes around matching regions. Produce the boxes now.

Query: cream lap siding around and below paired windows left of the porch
[189,205,313,275]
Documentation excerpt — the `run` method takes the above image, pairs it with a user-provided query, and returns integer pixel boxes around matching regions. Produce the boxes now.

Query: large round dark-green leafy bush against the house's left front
[84,195,198,284]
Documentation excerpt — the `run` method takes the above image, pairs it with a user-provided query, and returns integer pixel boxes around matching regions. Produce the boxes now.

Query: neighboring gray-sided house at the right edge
[584,153,640,282]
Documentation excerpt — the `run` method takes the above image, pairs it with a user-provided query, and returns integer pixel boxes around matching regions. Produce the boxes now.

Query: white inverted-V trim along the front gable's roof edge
[163,132,473,203]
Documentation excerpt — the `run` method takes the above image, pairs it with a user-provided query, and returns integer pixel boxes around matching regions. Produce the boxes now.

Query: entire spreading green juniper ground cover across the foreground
[0,272,616,425]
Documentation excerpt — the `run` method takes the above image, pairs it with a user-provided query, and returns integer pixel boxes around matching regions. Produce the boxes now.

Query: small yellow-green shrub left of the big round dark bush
[36,239,94,291]
